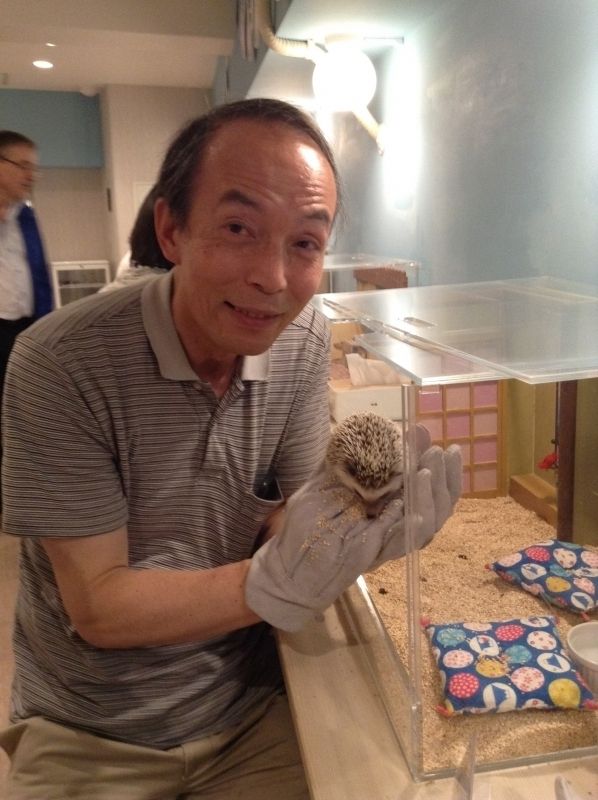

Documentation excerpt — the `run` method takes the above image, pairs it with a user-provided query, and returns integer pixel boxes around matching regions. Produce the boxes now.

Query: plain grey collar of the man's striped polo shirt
[141,271,270,381]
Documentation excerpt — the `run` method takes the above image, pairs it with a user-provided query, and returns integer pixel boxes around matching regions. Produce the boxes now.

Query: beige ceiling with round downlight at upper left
[0,0,236,94]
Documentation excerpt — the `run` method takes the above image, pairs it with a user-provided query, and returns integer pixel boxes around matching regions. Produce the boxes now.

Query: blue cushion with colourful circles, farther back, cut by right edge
[488,539,598,618]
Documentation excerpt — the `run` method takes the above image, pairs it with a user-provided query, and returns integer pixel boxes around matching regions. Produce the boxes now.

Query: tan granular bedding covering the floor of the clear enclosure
[366,497,598,773]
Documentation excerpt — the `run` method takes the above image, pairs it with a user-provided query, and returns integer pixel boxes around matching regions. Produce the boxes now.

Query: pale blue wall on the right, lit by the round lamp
[338,0,598,283]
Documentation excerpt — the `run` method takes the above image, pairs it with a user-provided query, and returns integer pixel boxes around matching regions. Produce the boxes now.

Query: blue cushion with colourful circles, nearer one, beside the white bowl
[424,617,598,716]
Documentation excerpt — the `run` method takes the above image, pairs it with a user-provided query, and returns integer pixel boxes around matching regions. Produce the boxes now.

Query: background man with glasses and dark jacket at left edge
[0,130,53,510]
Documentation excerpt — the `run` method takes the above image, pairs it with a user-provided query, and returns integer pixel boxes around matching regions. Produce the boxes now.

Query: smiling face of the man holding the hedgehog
[156,120,337,363]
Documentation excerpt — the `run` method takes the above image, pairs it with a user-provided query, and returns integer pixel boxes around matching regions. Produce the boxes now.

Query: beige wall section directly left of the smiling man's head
[101,86,209,267]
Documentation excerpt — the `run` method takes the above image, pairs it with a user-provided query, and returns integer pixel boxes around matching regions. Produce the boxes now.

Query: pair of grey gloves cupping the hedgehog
[245,425,461,631]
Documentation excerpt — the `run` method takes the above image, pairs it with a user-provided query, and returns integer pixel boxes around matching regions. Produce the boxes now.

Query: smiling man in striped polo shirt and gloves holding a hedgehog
[0,100,462,800]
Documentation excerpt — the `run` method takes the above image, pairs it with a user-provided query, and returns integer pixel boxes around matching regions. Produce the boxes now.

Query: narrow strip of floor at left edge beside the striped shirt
[0,530,19,800]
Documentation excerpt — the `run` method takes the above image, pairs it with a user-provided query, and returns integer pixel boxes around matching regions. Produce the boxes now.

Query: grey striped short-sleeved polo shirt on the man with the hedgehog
[3,274,329,749]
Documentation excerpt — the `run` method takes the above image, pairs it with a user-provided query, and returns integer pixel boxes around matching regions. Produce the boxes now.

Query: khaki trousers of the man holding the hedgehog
[0,696,309,800]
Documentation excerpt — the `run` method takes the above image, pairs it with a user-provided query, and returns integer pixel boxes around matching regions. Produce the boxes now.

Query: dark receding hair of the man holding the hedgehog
[156,98,341,226]
